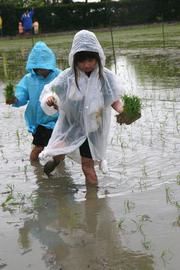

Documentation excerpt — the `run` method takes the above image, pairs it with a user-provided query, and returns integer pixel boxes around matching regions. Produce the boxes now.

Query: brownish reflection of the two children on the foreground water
[19,168,153,270]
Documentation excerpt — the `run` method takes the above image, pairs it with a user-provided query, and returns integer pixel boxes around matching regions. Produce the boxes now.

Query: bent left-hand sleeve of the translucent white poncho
[39,71,66,115]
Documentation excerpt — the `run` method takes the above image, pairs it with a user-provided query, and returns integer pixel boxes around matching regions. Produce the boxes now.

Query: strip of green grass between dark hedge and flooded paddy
[0,23,180,52]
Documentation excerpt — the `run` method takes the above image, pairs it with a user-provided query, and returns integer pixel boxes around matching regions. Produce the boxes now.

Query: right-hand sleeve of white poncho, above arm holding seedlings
[103,68,125,106]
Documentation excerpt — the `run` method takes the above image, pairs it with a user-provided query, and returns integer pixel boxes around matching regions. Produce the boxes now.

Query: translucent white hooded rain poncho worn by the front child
[40,30,121,169]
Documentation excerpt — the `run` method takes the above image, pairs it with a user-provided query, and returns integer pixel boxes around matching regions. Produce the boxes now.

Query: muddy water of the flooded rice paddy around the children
[0,43,180,270]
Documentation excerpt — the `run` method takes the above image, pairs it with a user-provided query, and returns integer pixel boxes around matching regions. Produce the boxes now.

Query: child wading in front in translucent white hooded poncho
[40,30,123,184]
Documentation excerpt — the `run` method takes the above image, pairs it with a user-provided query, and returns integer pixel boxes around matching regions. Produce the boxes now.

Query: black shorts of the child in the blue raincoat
[32,126,53,147]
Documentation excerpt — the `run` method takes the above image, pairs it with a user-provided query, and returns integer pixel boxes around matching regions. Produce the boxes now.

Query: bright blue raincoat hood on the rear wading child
[26,41,56,72]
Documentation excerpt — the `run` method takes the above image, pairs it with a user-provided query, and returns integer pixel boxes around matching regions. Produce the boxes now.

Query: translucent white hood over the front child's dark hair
[69,30,106,67]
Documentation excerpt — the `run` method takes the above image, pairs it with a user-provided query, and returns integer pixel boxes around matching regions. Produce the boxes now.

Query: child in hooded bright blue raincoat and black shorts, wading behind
[6,42,61,161]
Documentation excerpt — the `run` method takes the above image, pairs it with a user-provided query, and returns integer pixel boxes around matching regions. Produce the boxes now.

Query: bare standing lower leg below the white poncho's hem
[81,157,97,184]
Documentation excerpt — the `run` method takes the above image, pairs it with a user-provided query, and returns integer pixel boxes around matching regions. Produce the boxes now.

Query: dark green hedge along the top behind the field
[0,0,180,35]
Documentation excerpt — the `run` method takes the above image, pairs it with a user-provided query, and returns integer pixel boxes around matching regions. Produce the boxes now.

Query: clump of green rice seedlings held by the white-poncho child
[116,95,141,125]
